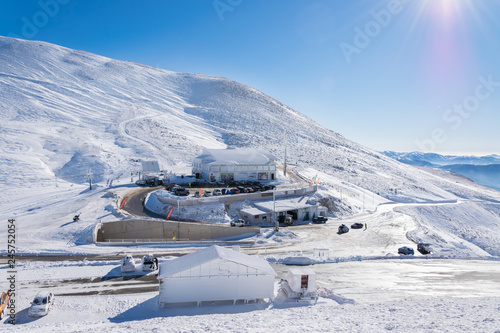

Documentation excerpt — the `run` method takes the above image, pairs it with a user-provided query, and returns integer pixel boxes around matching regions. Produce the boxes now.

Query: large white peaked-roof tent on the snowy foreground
[158,245,276,306]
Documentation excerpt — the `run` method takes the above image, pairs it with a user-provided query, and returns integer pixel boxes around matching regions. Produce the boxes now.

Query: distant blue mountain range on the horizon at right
[382,151,500,190]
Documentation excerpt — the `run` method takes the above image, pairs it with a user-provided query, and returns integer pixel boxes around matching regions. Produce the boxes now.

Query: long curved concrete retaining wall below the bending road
[96,220,260,242]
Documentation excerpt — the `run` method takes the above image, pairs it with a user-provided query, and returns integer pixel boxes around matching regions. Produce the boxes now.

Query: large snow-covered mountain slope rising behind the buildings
[0,37,500,253]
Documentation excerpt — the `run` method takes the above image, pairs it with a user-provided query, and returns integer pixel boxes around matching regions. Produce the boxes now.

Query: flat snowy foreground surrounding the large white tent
[8,259,500,332]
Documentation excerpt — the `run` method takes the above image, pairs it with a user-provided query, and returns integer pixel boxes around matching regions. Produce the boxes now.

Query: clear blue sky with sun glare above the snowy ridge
[0,0,500,154]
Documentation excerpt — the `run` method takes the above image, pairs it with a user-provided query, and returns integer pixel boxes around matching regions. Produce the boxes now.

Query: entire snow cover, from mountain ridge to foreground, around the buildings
[0,37,500,332]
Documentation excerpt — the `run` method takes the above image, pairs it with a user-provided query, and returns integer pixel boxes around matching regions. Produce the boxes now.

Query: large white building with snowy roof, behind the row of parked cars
[192,148,276,182]
